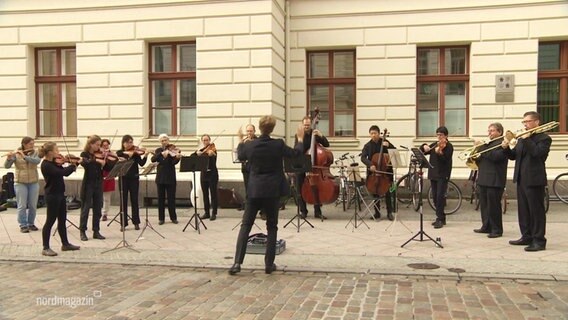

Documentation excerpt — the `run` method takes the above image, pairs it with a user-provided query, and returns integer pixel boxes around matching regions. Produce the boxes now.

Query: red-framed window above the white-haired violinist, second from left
[148,42,197,135]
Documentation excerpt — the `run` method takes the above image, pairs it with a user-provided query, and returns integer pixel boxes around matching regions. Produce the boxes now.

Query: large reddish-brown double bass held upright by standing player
[302,108,339,205]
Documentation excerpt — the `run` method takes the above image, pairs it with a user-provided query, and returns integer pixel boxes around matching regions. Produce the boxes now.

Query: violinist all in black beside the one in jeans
[39,142,80,257]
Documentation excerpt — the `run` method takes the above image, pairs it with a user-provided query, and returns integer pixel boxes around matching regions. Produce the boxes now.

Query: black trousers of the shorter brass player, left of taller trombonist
[478,185,505,234]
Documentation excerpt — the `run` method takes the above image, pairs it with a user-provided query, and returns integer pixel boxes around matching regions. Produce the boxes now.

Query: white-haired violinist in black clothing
[151,133,181,224]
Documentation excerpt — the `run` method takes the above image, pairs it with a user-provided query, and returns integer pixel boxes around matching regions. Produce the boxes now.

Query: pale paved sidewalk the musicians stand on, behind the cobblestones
[0,201,568,280]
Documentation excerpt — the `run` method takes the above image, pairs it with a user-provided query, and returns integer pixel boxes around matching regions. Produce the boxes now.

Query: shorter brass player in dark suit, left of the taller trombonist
[473,122,509,238]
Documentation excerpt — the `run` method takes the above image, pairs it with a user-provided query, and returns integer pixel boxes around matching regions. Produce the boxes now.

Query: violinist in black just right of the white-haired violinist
[195,134,219,221]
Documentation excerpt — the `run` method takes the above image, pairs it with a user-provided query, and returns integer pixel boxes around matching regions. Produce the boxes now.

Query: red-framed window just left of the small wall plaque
[416,47,469,136]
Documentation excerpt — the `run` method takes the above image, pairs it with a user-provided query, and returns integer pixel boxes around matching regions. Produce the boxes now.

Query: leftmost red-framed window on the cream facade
[35,48,77,137]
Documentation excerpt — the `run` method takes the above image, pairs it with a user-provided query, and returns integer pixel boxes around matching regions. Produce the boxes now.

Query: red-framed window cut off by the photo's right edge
[537,41,568,132]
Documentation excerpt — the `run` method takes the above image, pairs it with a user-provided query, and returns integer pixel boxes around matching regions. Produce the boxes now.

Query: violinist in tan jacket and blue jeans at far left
[4,137,41,233]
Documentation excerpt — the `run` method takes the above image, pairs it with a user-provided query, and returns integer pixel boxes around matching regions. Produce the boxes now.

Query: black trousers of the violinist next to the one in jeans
[41,194,69,249]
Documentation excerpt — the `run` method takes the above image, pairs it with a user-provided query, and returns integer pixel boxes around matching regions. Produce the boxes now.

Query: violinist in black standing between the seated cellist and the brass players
[420,126,454,229]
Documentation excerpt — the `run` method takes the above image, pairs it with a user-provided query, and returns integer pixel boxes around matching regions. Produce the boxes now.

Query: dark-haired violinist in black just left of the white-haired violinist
[116,134,148,230]
